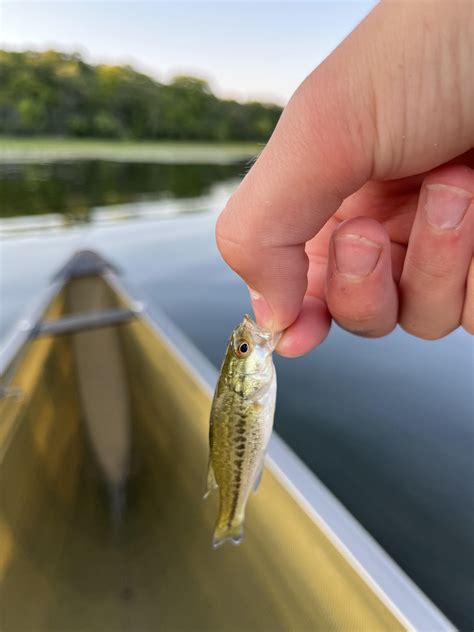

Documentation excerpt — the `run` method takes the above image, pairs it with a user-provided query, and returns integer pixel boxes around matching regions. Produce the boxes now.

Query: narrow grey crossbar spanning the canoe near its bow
[31,308,141,338]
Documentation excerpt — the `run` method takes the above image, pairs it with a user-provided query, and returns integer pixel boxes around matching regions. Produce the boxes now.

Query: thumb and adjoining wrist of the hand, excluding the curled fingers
[216,2,474,330]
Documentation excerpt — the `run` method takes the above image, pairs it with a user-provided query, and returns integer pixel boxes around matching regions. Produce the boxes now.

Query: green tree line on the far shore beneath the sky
[0,50,281,142]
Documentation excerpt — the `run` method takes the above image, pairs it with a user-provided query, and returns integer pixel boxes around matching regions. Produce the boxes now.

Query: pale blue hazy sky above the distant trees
[0,0,375,103]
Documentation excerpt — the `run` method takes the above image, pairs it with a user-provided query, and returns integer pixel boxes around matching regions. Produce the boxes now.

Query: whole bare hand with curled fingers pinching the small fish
[217,0,474,356]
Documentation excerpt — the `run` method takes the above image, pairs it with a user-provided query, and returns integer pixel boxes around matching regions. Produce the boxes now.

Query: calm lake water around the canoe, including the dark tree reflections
[0,161,474,630]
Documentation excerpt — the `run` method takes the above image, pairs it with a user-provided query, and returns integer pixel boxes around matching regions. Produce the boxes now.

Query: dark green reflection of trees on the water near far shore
[0,160,245,224]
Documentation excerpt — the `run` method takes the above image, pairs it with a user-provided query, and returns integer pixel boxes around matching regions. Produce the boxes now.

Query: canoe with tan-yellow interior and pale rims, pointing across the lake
[0,251,454,632]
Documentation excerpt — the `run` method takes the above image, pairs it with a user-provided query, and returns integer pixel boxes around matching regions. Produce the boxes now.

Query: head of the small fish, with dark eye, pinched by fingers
[228,314,280,386]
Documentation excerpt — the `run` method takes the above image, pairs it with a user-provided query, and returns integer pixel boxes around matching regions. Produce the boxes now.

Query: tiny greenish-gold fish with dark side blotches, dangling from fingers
[204,315,280,547]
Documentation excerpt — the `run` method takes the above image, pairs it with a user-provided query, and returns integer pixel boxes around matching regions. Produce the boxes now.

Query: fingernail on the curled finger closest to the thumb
[334,234,382,279]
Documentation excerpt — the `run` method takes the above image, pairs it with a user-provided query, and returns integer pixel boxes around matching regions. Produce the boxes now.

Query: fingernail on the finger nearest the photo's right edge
[425,184,474,230]
